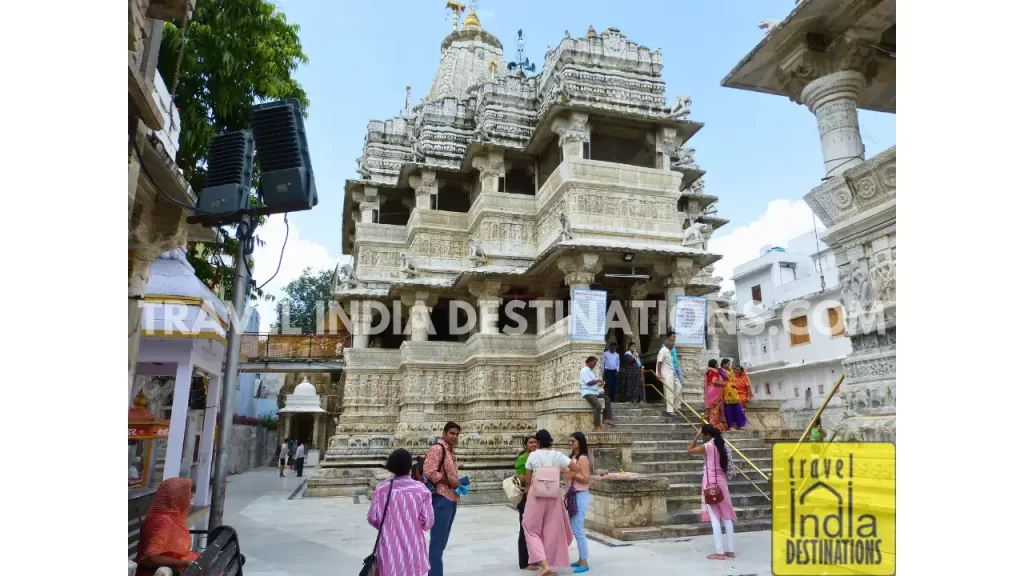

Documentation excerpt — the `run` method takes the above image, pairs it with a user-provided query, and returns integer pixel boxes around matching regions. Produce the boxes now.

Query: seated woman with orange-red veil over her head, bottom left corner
[137,478,199,576]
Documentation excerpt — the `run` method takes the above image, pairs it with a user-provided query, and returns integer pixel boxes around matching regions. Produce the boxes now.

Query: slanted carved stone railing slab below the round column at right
[804,146,896,228]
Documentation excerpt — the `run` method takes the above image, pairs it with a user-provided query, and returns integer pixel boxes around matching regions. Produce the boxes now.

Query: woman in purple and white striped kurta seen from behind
[367,448,434,576]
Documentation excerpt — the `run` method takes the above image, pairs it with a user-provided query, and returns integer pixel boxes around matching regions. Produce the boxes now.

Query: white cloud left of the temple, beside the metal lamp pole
[247,214,338,332]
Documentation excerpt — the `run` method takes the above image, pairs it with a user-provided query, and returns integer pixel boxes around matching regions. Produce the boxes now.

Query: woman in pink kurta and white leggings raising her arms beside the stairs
[686,424,736,560]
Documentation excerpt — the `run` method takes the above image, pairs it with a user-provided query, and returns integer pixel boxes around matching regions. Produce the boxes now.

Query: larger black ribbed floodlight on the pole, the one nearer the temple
[250,98,318,214]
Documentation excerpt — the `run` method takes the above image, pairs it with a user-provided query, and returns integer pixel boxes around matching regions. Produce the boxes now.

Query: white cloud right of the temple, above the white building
[708,200,821,291]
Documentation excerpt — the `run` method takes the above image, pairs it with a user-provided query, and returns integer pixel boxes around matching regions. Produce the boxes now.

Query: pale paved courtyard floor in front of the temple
[224,468,771,576]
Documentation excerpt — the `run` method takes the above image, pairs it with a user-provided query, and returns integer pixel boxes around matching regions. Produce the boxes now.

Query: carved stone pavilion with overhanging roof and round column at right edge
[722,0,896,442]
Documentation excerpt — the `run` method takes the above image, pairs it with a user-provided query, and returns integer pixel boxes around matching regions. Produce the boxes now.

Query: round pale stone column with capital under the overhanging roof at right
[801,70,867,177]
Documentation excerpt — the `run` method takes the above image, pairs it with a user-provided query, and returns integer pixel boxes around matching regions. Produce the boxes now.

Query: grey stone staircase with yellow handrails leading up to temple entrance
[595,404,771,540]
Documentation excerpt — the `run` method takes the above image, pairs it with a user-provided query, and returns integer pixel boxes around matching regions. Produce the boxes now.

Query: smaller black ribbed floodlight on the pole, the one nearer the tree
[198,130,255,216]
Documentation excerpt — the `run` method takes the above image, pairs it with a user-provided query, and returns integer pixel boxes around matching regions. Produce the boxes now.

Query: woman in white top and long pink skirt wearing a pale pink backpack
[522,430,580,576]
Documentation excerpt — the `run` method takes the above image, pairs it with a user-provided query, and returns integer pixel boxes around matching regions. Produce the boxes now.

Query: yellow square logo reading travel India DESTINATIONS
[771,442,896,576]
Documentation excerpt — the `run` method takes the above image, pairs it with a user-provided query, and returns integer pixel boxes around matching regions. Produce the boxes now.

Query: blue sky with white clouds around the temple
[249,0,896,328]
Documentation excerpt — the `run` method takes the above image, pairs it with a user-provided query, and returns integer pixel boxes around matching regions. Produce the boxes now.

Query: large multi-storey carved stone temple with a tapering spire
[306,10,727,503]
